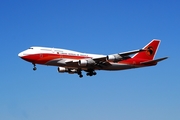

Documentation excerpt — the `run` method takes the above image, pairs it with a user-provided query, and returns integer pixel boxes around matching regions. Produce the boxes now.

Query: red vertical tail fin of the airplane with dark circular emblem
[133,40,160,60]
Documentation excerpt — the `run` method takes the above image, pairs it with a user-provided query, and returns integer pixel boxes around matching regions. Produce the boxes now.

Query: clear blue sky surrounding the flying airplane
[0,0,180,120]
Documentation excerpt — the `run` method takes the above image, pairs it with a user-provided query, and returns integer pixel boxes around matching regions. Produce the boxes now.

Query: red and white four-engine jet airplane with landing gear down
[18,39,168,78]
